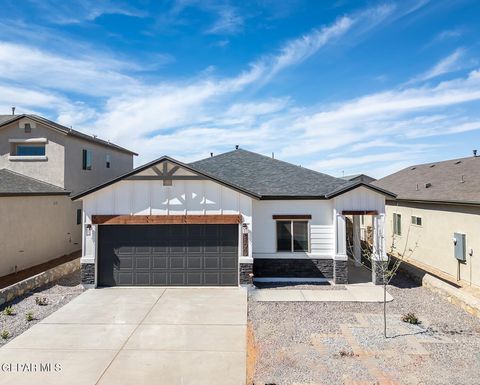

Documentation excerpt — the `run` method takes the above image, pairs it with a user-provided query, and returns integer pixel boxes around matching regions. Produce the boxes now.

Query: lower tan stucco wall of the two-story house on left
[0,196,82,276]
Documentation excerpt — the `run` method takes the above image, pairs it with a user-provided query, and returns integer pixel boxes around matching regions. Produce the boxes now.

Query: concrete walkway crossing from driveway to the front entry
[251,283,393,302]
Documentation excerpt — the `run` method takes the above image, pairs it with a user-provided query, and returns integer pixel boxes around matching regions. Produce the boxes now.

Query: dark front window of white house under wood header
[277,221,308,252]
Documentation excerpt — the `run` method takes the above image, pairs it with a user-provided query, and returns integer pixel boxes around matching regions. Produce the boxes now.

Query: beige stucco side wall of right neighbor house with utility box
[386,202,480,286]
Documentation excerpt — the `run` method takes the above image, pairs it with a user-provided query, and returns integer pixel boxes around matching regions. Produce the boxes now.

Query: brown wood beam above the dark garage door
[92,215,242,225]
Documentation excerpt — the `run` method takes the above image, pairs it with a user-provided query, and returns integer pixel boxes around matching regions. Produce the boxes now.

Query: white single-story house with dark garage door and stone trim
[73,148,394,286]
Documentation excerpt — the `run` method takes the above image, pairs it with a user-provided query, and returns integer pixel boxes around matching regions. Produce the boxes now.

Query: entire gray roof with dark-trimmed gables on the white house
[72,149,394,200]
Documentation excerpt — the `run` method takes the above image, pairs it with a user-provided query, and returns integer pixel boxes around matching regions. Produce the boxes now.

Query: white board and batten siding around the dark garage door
[83,180,252,262]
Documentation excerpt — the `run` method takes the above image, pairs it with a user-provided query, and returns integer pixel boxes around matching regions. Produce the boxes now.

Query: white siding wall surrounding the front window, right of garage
[252,200,335,259]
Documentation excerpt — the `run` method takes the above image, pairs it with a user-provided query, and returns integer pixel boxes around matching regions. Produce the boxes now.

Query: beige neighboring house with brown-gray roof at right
[373,154,480,286]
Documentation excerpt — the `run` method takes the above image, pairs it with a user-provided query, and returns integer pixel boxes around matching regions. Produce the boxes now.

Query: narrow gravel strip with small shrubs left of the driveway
[0,271,84,346]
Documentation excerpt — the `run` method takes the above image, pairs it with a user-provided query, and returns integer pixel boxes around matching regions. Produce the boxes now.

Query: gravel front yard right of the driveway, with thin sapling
[248,275,480,385]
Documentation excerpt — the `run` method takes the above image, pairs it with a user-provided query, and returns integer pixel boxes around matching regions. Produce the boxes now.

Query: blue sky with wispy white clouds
[0,0,480,177]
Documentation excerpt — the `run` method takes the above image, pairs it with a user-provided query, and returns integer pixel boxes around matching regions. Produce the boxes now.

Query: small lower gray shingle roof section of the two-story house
[0,168,70,196]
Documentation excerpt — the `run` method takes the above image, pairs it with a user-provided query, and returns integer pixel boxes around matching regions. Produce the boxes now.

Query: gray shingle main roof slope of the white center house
[190,149,347,198]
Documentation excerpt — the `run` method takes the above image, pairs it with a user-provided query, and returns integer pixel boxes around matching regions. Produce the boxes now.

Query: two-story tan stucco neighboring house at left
[0,114,136,276]
